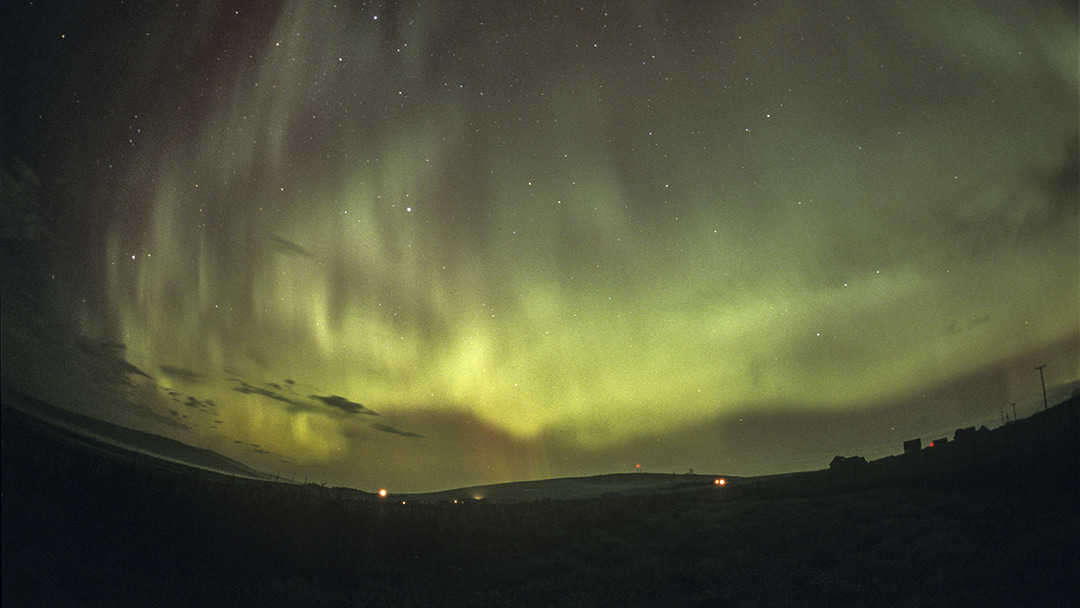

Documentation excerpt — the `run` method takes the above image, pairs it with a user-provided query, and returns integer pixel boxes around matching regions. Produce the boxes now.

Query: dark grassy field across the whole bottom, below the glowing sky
[2,400,1080,607]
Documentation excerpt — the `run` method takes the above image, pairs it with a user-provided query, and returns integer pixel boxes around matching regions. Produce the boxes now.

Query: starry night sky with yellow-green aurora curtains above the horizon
[2,0,1080,491]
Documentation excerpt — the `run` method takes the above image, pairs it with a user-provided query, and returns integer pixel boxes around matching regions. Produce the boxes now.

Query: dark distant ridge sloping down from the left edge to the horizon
[0,387,267,479]
